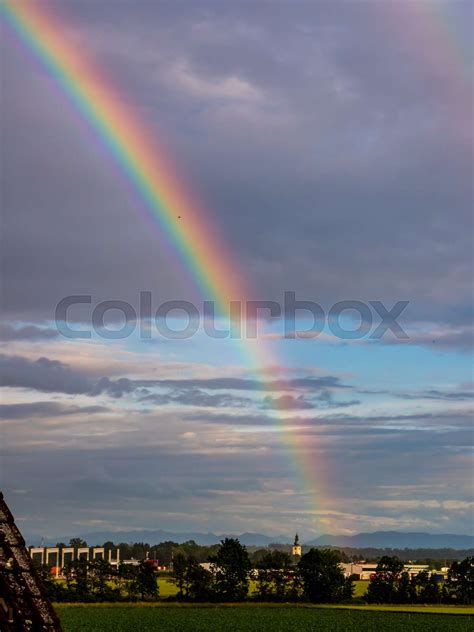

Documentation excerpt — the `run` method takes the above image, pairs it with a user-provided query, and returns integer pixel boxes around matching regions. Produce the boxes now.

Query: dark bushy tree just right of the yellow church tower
[297,548,354,603]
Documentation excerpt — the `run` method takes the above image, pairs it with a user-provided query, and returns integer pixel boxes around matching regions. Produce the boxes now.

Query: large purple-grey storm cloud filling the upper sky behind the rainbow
[2,2,472,336]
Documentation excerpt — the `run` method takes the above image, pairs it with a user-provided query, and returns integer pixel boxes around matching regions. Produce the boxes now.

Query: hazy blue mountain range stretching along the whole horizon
[27,530,474,549]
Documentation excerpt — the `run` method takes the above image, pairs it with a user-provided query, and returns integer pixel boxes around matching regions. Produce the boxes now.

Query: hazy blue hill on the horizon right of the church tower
[306,531,474,549]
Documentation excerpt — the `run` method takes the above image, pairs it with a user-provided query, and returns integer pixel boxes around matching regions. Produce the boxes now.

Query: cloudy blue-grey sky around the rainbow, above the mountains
[0,0,473,539]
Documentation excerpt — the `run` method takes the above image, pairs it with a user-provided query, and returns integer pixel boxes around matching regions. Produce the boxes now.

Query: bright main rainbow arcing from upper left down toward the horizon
[0,0,324,528]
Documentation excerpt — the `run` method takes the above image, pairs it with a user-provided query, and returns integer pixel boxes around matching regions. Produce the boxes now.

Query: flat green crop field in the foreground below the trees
[57,604,474,632]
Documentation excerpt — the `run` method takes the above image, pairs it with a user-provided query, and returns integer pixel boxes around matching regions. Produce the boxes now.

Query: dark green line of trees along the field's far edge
[38,538,474,604]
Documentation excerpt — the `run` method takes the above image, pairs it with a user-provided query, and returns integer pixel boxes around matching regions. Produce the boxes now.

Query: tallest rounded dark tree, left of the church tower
[209,538,251,601]
